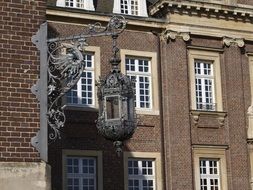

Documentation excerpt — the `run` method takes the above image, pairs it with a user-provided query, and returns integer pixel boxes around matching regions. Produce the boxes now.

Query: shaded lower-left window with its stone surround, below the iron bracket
[63,150,103,190]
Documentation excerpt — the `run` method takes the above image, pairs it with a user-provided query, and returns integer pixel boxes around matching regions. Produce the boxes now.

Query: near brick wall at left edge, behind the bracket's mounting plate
[0,0,46,162]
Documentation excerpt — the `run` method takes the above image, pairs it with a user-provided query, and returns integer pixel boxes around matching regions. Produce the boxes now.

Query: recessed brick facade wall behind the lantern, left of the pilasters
[49,23,161,190]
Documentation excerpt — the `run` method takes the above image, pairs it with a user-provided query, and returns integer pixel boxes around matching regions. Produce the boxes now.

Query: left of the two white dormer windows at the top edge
[56,0,95,11]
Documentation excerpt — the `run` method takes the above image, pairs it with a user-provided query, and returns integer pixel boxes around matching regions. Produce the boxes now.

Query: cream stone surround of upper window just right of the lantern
[120,49,159,115]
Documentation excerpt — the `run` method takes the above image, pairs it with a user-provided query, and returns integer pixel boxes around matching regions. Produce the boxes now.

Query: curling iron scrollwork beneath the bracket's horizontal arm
[47,39,86,140]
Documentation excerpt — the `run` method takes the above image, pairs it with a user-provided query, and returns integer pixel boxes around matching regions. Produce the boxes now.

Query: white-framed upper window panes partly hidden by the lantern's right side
[126,57,152,108]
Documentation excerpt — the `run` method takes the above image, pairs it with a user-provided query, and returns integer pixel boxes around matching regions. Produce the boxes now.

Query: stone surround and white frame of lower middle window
[124,152,163,190]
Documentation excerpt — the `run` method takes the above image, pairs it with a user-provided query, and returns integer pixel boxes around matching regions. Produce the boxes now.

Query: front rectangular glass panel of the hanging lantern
[105,95,121,119]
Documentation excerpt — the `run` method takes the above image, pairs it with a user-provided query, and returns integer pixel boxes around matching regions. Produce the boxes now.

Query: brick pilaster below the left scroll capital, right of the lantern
[161,39,193,190]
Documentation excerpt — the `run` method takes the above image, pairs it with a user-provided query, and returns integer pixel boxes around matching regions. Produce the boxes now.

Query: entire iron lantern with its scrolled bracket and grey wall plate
[32,16,136,161]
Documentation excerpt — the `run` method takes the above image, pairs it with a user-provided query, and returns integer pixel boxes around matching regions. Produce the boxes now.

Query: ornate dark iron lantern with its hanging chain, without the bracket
[97,35,136,155]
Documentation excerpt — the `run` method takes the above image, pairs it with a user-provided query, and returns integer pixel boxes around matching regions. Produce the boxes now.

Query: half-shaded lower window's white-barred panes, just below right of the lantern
[128,159,155,190]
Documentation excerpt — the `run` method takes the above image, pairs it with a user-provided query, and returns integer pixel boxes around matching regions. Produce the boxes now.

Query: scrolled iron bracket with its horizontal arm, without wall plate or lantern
[47,16,126,141]
